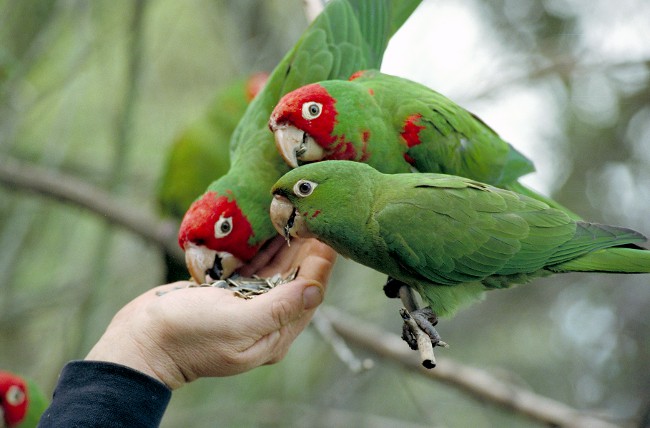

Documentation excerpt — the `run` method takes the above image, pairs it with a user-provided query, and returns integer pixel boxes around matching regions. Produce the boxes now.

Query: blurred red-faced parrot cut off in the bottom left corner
[0,370,48,428]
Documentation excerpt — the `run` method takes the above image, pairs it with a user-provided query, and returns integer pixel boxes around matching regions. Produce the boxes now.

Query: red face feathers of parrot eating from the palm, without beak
[178,192,258,261]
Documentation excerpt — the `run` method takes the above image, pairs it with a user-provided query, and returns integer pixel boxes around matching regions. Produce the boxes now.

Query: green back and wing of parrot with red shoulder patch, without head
[344,70,535,186]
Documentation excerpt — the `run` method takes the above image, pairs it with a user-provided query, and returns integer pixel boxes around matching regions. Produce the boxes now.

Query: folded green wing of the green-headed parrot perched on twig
[375,174,575,285]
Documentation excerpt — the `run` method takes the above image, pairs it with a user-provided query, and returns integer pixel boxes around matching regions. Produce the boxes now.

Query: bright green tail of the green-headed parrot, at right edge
[548,247,650,273]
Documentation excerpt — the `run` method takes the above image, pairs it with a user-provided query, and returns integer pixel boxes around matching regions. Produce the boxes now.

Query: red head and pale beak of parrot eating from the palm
[178,191,261,284]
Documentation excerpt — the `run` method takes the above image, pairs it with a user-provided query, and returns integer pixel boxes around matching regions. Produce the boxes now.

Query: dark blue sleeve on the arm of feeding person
[38,361,171,428]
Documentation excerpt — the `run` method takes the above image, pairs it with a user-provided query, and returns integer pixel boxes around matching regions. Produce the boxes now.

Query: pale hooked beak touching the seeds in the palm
[185,243,244,284]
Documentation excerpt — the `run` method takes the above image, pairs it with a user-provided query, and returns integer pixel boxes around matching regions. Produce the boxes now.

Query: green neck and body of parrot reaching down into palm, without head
[208,0,421,244]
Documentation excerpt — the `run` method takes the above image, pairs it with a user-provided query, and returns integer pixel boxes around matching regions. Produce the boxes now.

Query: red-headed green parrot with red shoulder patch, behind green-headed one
[269,70,578,219]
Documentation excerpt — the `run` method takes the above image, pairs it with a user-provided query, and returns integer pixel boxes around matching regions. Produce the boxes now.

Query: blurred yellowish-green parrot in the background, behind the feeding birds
[157,72,268,220]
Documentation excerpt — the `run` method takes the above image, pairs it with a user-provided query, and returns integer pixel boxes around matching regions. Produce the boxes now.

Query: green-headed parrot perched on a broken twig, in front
[270,161,650,347]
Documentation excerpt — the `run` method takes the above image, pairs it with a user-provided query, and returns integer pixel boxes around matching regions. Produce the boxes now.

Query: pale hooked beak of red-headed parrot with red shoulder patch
[273,125,326,168]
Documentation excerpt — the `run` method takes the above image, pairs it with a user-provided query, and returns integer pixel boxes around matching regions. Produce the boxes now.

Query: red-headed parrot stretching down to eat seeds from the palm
[178,0,420,283]
